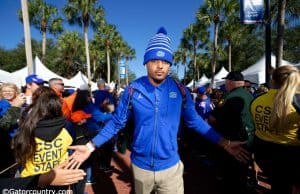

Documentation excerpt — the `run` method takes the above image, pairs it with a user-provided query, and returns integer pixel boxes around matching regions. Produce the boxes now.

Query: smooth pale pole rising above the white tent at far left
[21,0,34,74]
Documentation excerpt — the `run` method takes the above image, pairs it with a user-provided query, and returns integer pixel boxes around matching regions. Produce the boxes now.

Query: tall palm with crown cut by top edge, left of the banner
[197,0,238,85]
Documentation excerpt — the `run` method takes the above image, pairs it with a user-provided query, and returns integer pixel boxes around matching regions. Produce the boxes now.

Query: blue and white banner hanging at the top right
[240,0,264,24]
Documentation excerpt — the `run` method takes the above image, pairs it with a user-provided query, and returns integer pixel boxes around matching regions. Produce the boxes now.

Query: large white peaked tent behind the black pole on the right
[242,55,292,84]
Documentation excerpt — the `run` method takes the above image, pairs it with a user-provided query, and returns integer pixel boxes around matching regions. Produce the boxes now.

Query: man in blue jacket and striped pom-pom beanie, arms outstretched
[71,28,248,194]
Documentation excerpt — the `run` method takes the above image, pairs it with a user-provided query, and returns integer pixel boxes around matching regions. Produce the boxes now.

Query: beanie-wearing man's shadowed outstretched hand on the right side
[223,141,250,163]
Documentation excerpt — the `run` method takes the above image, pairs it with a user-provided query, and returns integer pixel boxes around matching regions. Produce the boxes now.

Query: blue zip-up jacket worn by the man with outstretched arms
[92,76,221,171]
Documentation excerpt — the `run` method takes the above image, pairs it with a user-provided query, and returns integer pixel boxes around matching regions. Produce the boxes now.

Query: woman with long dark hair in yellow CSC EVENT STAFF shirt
[13,86,72,189]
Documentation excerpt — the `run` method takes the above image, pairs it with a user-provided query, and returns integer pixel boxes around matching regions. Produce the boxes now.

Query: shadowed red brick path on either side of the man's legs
[85,151,218,194]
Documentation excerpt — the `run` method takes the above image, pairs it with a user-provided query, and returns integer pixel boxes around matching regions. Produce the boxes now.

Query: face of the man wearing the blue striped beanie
[146,60,170,85]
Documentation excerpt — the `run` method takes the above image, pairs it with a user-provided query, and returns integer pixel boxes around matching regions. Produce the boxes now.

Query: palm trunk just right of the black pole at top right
[276,0,286,67]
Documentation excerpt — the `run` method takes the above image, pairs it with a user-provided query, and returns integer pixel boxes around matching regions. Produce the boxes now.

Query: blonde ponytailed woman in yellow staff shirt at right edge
[251,65,300,194]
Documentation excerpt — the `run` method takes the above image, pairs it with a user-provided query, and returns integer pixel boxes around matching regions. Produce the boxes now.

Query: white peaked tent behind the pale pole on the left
[11,56,70,85]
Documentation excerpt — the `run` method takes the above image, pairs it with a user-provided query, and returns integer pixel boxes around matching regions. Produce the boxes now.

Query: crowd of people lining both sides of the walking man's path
[0,66,300,194]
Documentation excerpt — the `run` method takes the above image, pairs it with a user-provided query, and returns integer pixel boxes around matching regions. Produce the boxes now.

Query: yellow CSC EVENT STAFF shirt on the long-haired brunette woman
[21,128,72,177]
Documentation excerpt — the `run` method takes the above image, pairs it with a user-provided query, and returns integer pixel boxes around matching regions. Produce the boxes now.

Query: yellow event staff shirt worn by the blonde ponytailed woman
[251,89,300,145]
